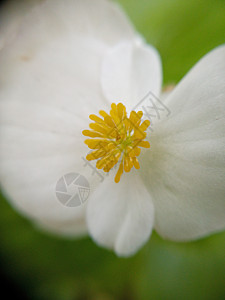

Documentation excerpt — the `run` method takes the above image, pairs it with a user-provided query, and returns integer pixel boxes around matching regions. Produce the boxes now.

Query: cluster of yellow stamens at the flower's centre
[82,103,150,183]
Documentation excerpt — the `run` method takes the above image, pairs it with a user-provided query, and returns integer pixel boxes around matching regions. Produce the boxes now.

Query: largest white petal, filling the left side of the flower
[0,0,144,235]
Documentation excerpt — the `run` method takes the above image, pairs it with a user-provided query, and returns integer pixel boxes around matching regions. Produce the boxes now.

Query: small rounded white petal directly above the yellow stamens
[102,41,162,110]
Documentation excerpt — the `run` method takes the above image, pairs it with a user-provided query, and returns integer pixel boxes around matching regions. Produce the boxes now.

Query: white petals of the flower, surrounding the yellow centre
[0,0,225,256]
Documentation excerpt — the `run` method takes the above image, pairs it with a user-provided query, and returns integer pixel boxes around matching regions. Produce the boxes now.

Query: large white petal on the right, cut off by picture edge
[141,46,225,241]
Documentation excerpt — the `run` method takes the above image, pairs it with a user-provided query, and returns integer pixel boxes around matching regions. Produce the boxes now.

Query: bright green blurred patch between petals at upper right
[119,0,225,84]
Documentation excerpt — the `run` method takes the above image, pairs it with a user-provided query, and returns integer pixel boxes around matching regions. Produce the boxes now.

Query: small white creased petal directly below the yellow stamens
[87,170,154,256]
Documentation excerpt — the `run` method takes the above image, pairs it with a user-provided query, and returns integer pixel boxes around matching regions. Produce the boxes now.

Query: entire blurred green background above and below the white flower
[0,0,225,300]
